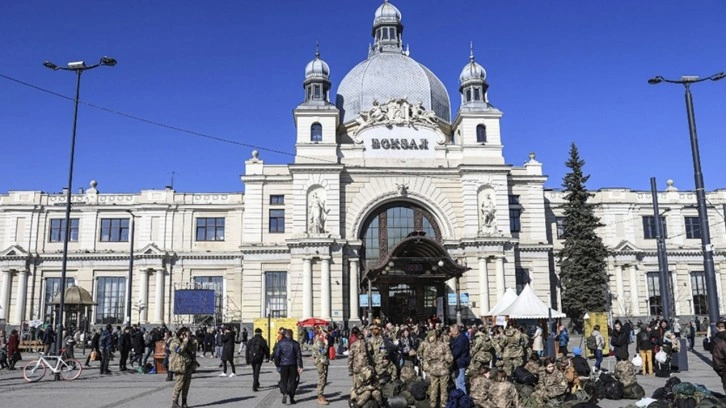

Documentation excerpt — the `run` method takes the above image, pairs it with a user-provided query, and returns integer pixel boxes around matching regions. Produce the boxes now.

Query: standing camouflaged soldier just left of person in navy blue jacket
[421,330,454,408]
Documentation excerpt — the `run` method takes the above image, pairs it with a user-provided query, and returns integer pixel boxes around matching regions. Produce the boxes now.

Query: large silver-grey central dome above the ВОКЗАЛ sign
[336,52,451,123]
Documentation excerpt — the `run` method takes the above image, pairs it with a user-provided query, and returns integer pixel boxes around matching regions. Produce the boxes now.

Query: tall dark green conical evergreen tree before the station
[559,143,609,320]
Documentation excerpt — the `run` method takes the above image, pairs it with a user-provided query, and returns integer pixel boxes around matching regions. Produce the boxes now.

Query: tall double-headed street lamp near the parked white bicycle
[43,57,116,352]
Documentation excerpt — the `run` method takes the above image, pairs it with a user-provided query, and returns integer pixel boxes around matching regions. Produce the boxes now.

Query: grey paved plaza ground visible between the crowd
[0,339,721,408]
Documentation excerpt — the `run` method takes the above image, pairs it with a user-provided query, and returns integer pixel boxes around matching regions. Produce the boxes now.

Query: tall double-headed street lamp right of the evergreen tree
[648,72,726,333]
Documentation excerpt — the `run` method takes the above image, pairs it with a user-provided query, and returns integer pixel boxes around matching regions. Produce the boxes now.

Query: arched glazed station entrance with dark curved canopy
[360,201,469,323]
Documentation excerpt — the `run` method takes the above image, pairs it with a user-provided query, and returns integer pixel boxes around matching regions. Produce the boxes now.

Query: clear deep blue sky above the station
[0,0,726,193]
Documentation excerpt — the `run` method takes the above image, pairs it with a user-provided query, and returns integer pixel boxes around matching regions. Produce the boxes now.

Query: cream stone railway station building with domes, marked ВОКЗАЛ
[0,2,726,324]
